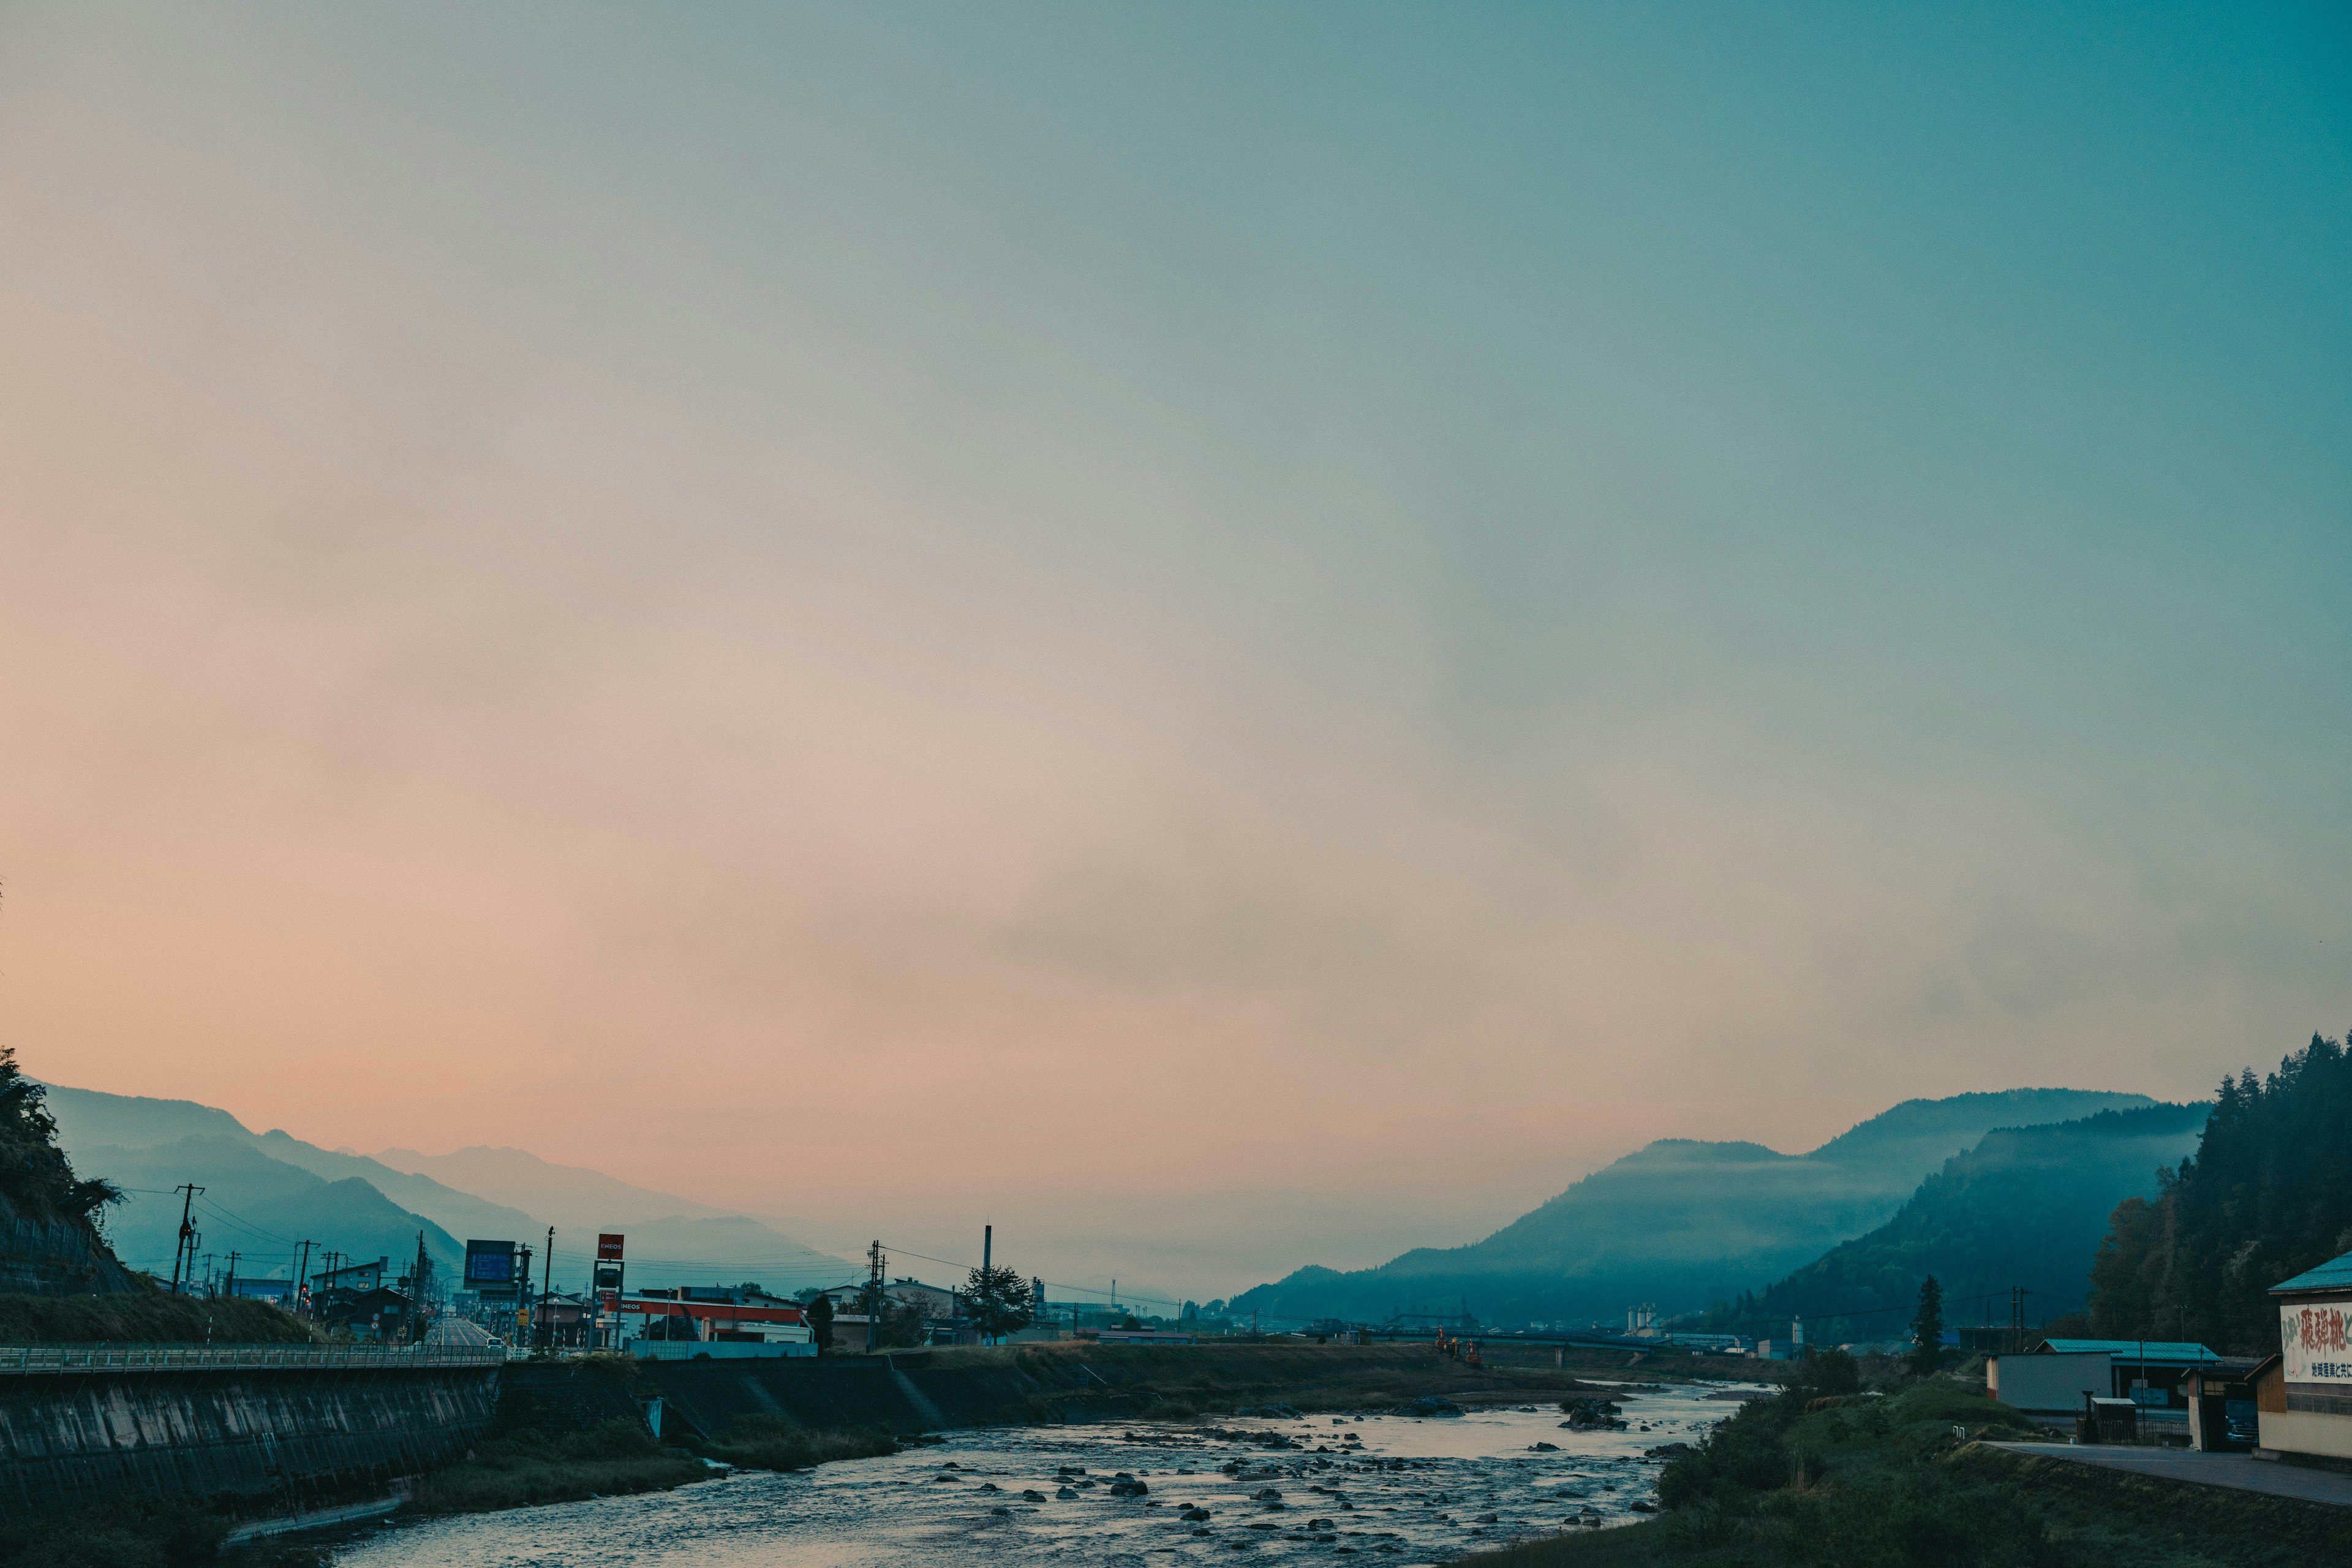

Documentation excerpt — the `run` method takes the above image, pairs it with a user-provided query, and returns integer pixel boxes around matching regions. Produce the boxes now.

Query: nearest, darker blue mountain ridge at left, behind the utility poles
[89,1138,466,1279]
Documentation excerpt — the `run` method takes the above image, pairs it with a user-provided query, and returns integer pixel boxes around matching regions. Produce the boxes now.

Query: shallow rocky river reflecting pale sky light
[334,1387,1733,1568]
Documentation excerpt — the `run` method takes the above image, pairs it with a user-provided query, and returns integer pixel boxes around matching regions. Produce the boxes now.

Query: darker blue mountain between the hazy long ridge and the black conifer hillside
[1713,1102,2213,1343]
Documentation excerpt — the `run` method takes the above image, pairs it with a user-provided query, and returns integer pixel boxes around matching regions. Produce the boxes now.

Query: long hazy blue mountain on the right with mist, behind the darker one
[1235,1088,2154,1326]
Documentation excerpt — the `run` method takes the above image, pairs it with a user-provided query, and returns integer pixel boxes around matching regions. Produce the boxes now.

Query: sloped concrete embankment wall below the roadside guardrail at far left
[0,1366,499,1514]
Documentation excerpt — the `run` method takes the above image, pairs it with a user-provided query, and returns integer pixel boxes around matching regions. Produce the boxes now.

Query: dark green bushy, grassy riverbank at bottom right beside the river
[1475,1378,2352,1568]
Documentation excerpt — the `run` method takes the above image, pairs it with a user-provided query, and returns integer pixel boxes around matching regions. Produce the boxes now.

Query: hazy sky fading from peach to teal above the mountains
[0,2,2352,1300]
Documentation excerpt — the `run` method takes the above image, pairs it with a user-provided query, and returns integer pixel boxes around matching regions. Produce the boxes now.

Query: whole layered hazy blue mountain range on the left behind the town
[47,1084,859,1291]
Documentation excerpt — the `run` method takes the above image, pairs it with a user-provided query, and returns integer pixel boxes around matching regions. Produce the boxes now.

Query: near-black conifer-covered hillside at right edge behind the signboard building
[2091,1035,2352,1354]
